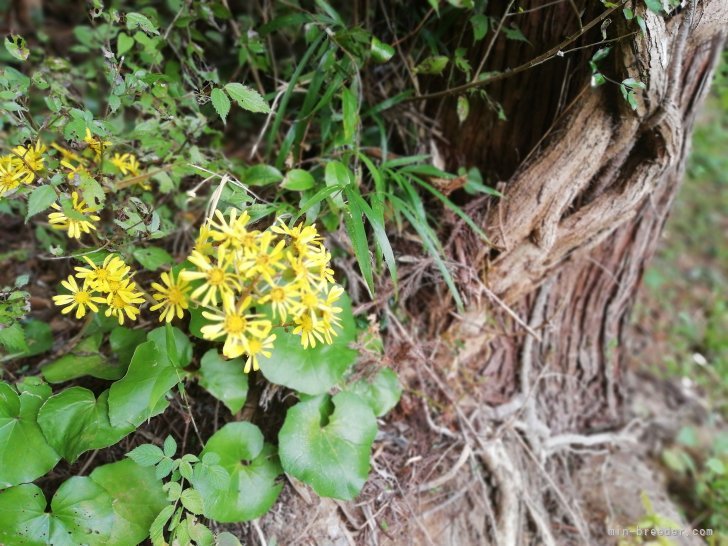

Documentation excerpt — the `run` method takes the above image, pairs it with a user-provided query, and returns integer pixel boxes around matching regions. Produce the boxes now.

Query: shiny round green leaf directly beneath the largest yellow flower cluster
[259,296,357,394]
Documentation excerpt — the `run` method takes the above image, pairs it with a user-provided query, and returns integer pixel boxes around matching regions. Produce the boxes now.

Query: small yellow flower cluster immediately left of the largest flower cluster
[53,254,144,324]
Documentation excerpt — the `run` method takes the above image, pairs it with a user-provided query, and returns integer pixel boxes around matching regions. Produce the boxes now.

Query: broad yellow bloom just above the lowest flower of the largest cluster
[201,295,272,358]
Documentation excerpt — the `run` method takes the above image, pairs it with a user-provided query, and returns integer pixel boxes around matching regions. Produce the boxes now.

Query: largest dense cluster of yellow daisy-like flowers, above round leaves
[152,209,343,373]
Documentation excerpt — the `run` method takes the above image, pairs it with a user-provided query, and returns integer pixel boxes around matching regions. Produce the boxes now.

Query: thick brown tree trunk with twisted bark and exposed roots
[253,0,728,545]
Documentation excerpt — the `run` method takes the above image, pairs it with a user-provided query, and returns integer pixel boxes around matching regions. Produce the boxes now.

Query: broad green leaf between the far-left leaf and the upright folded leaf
[38,387,134,462]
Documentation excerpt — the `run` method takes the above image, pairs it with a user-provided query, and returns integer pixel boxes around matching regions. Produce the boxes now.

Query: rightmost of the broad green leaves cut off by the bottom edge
[89,459,167,546]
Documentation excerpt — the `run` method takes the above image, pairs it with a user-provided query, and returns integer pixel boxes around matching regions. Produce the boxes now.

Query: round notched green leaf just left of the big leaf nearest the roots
[192,422,283,523]
